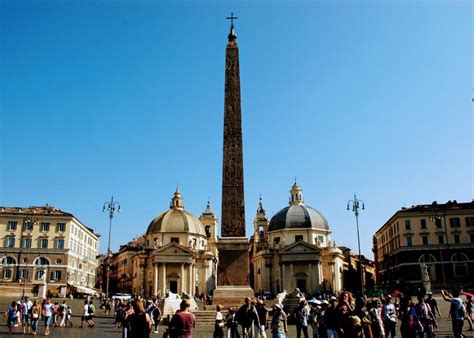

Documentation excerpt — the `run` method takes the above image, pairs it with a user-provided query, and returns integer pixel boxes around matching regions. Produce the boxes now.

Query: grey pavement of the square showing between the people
[0,297,474,338]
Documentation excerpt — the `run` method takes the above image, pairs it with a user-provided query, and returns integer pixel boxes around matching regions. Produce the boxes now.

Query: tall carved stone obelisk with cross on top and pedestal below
[214,13,253,306]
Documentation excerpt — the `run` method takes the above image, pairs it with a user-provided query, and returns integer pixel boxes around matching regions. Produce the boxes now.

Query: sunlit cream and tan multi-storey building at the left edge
[0,205,100,295]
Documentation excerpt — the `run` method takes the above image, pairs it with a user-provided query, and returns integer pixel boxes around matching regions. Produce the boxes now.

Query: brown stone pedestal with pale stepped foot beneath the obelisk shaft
[213,237,254,308]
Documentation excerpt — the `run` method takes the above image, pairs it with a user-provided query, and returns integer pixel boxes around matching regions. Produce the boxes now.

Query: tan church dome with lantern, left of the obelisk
[146,190,206,236]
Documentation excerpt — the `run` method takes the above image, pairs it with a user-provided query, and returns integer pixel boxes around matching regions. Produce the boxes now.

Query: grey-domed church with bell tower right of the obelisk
[250,182,344,294]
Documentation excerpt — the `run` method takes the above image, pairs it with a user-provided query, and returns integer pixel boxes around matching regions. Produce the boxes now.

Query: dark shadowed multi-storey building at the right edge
[373,201,474,288]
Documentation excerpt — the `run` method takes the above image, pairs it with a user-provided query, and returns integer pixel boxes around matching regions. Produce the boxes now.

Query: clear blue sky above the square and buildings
[0,0,474,257]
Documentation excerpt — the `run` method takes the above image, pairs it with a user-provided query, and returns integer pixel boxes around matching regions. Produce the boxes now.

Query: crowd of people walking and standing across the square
[4,290,473,338]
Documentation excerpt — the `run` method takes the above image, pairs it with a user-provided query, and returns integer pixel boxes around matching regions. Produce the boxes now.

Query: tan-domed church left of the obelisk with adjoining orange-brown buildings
[110,190,218,296]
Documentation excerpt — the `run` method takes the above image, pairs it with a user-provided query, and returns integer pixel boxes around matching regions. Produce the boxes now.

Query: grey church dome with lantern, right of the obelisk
[268,182,329,231]
